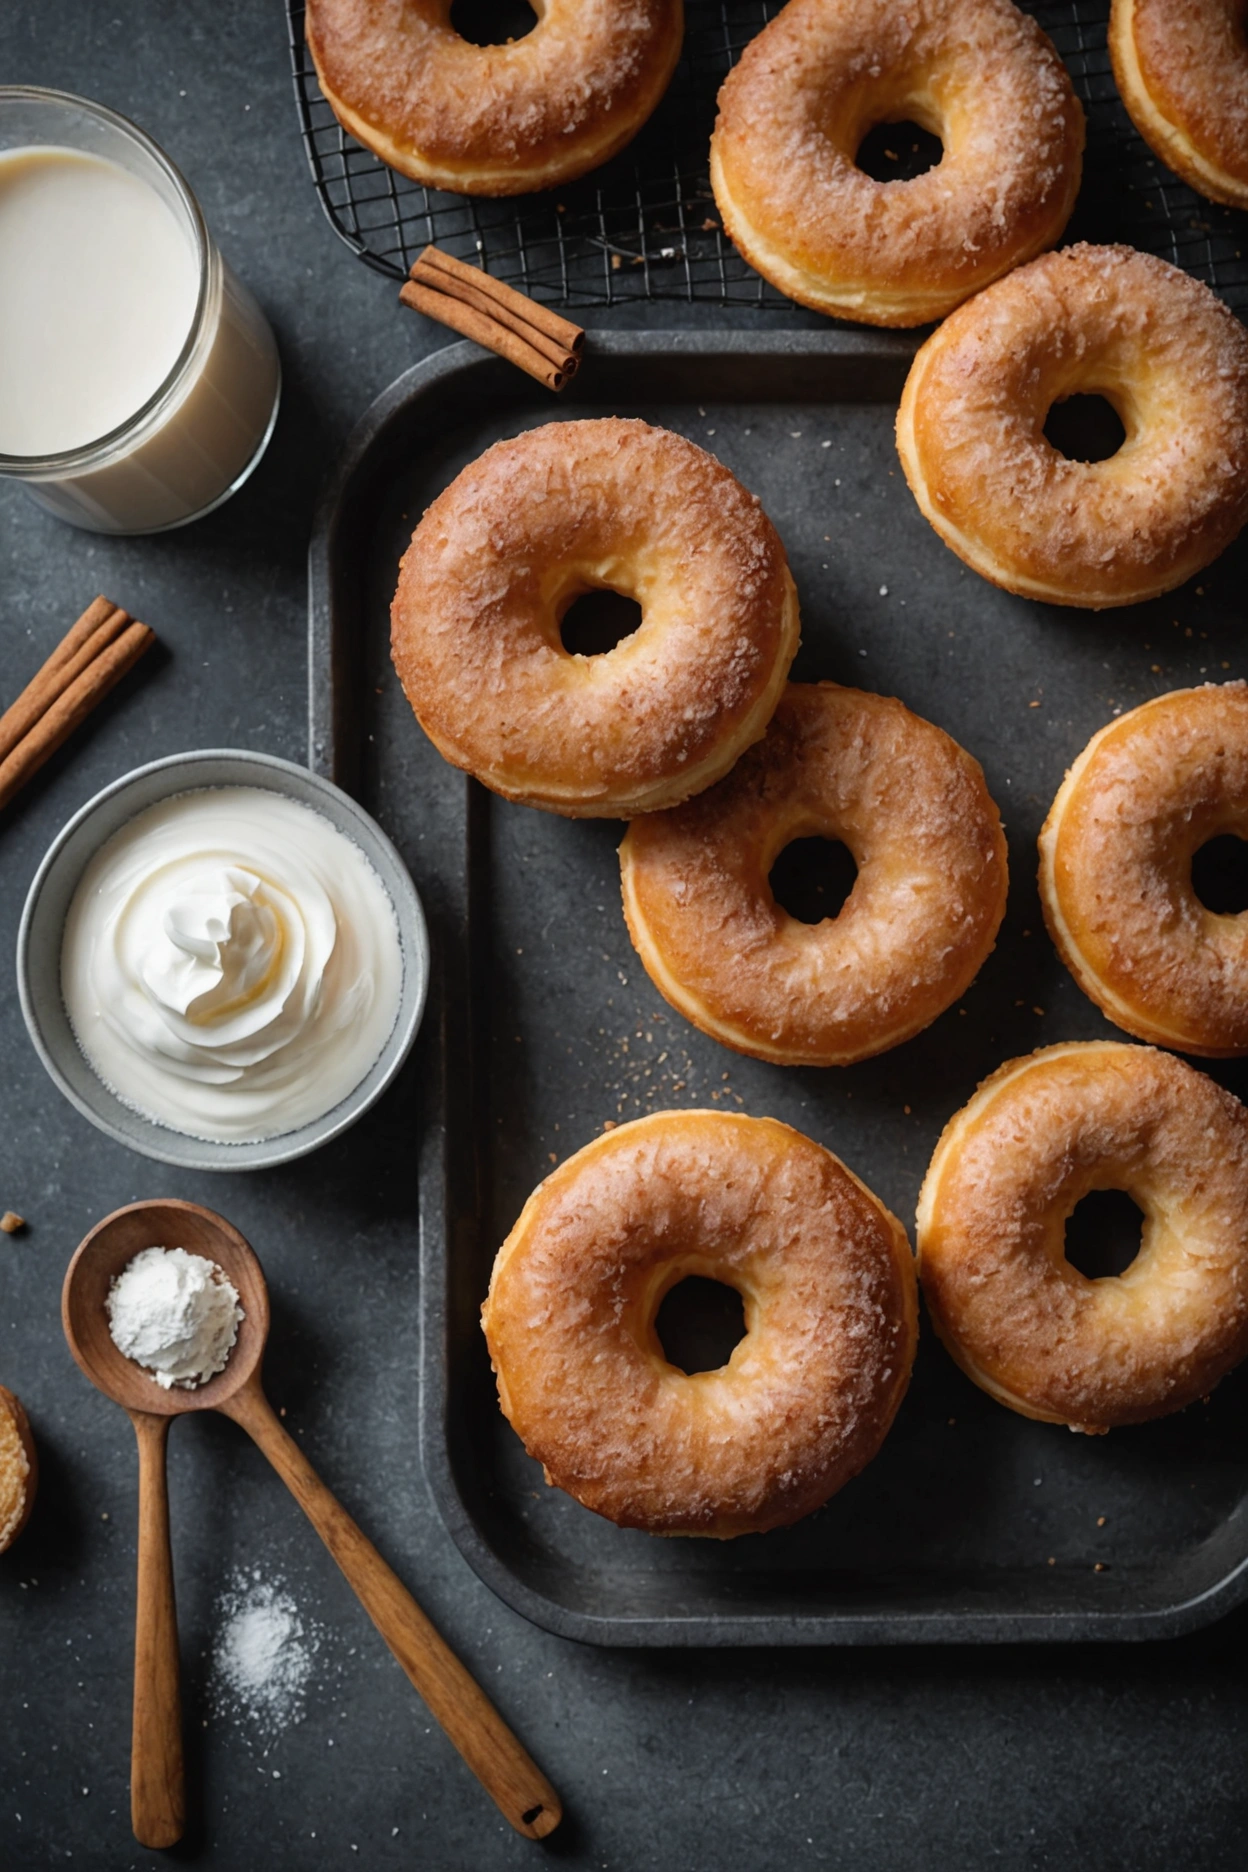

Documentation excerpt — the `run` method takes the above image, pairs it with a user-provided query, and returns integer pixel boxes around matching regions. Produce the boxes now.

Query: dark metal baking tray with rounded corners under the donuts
[311,331,1248,1645]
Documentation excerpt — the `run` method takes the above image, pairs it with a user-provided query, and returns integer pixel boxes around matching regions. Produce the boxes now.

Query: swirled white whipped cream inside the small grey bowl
[62,786,402,1144]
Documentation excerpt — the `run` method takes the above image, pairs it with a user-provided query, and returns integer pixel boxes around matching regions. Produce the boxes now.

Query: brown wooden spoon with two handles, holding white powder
[62,1202,563,1846]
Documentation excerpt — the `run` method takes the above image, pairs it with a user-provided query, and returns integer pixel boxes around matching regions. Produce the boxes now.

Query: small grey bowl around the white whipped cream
[17,749,428,1170]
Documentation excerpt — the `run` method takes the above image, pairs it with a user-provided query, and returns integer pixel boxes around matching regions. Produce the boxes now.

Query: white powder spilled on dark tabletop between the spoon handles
[210,1569,322,1741]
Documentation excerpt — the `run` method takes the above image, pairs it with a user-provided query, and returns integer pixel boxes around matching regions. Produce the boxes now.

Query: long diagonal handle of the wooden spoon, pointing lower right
[219,1383,563,1840]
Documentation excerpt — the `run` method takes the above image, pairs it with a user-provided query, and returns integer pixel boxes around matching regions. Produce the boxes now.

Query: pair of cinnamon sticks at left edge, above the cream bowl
[0,597,155,807]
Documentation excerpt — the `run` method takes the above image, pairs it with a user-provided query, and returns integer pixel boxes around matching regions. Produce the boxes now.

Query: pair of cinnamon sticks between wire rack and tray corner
[399,247,586,389]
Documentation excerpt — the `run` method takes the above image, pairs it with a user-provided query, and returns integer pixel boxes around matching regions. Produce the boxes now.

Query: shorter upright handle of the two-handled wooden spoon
[129,1410,185,1848]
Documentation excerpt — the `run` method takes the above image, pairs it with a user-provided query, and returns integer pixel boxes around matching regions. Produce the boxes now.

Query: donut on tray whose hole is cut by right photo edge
[1040,681,1248,1060]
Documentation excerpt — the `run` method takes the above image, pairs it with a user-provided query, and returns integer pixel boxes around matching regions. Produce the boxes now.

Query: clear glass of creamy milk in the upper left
[0,84,281,534]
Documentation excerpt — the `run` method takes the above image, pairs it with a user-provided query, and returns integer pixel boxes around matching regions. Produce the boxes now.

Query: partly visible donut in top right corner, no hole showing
[1110,0,1248,208]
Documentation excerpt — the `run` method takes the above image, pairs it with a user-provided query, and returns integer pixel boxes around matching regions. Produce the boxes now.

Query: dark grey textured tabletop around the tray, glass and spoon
[0,0,1248,1872]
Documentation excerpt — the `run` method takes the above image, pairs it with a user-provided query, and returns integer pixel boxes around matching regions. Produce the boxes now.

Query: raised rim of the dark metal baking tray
[307,328,1248,1649]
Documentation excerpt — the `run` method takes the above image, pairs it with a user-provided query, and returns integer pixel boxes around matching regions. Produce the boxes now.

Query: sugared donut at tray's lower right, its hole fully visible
[919,1041,1248,1434]
